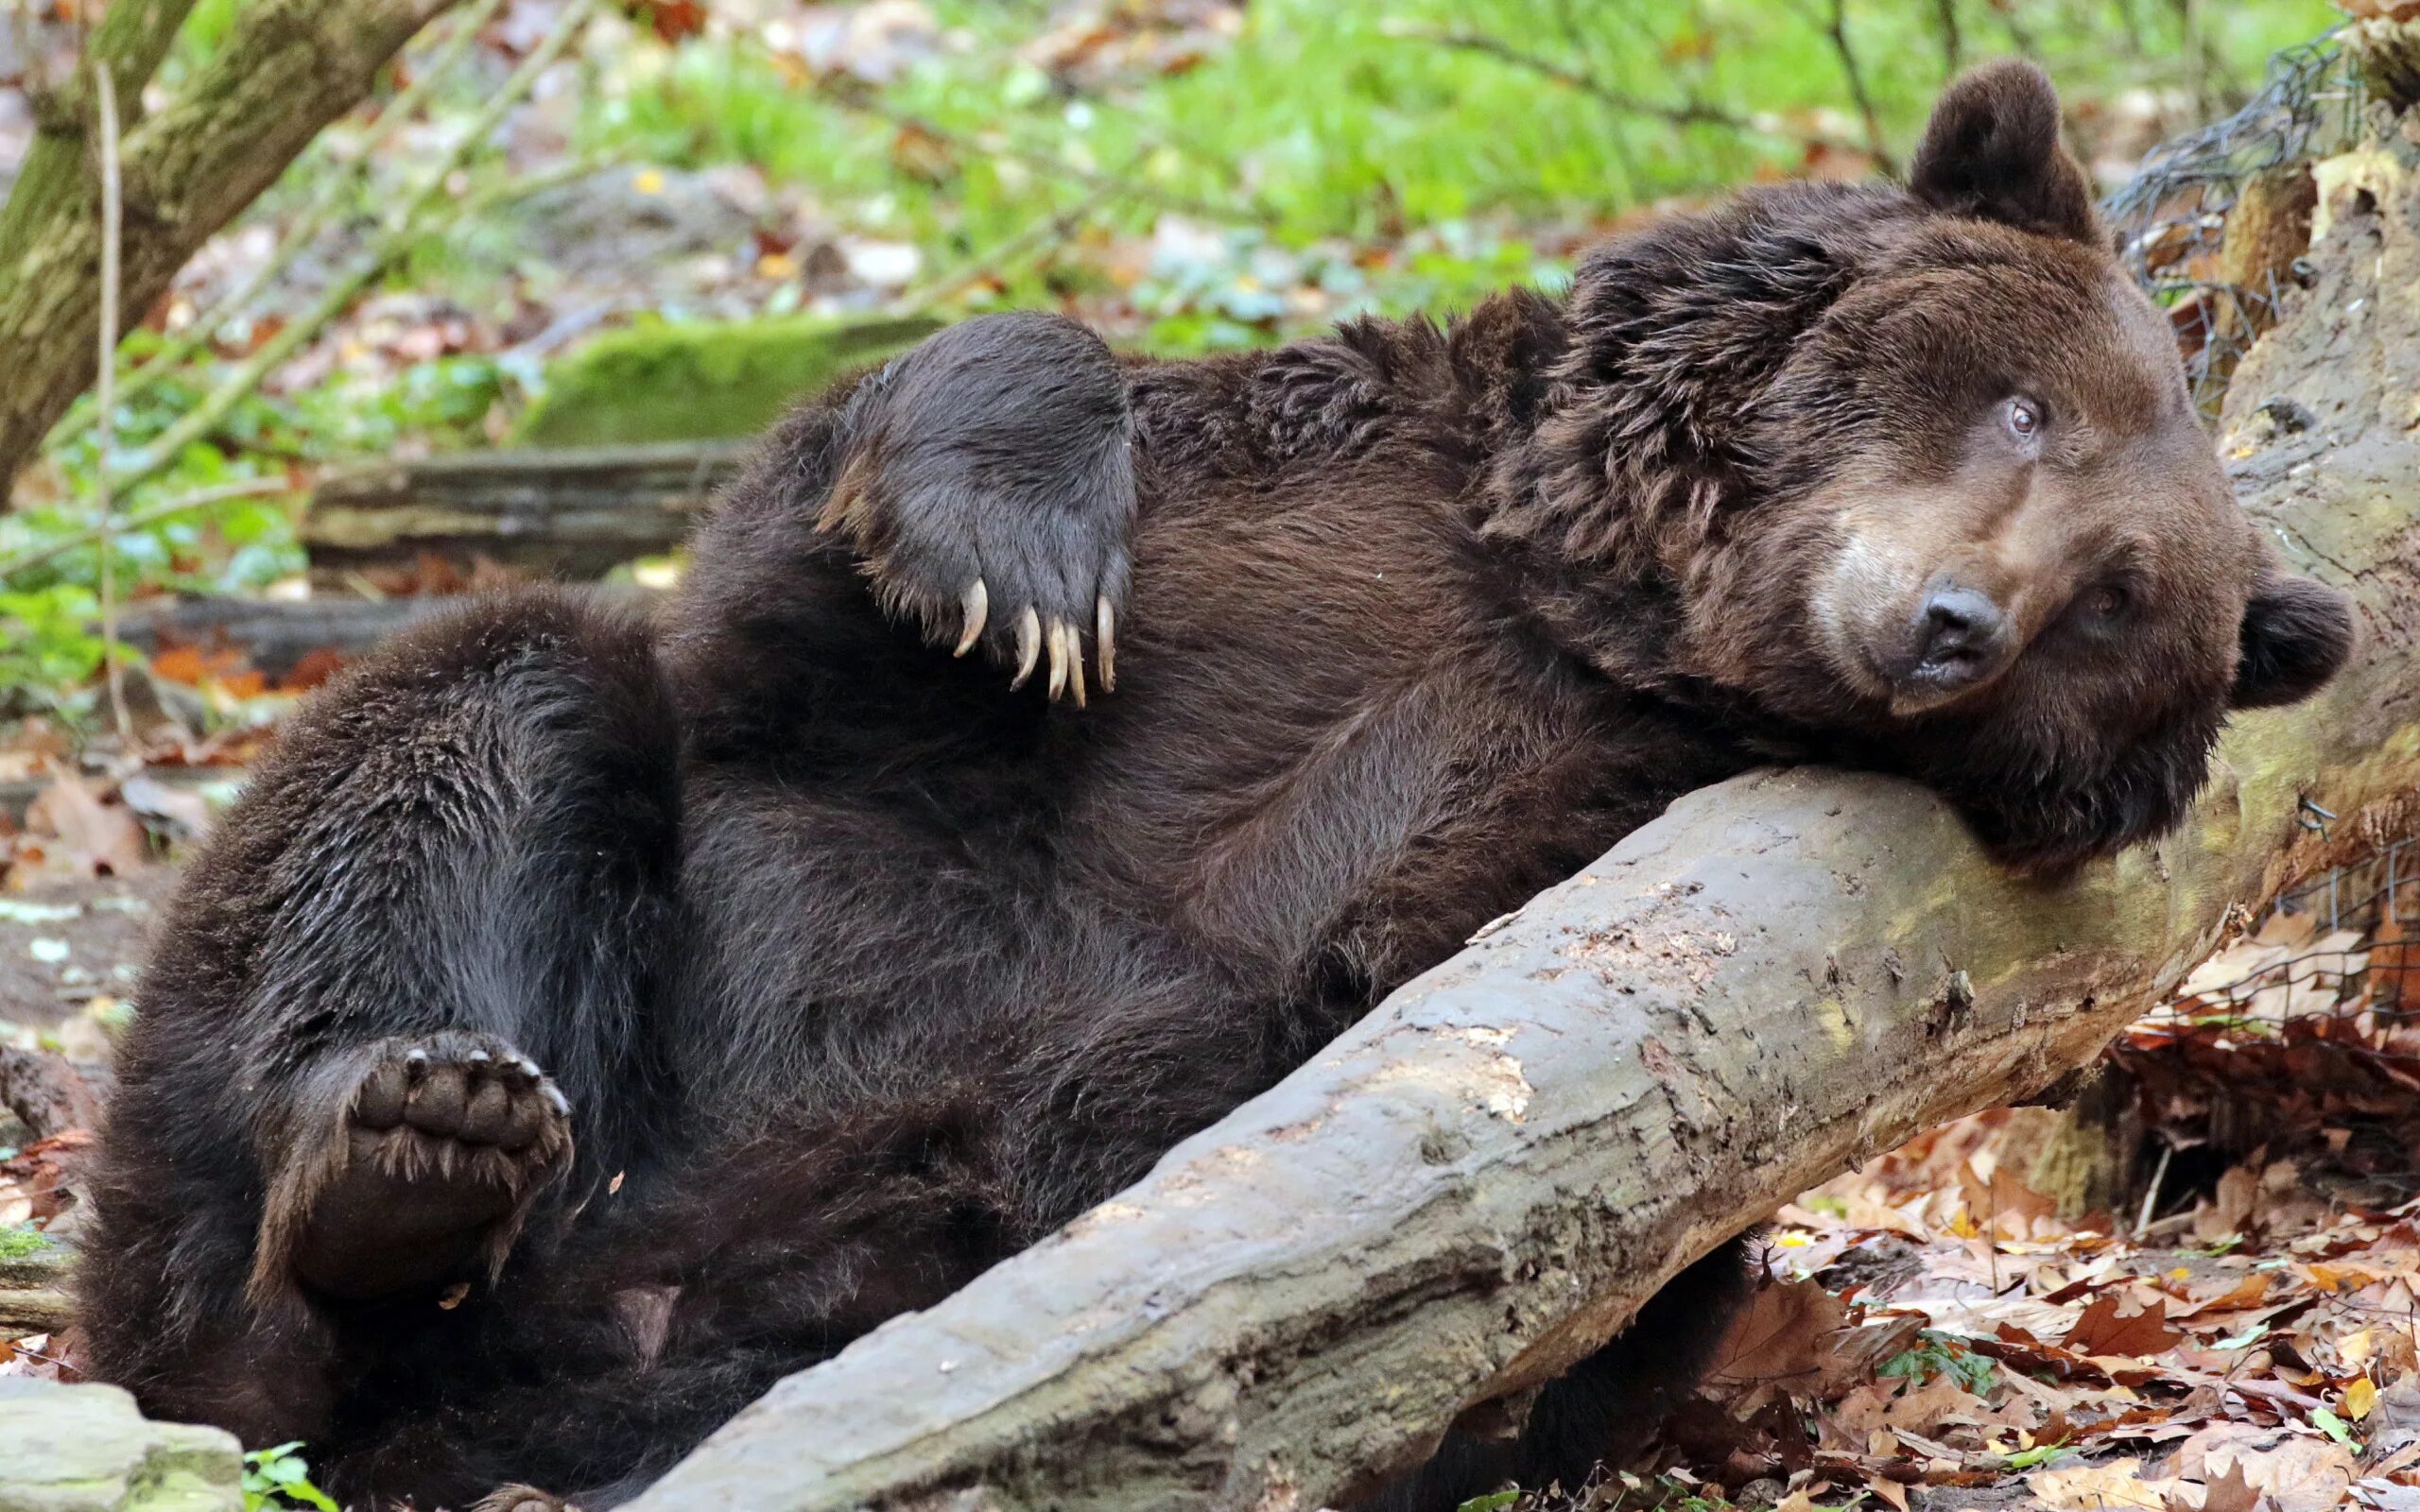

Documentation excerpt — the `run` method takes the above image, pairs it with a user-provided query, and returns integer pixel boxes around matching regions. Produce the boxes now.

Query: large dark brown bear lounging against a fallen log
[82,63,2352,1507]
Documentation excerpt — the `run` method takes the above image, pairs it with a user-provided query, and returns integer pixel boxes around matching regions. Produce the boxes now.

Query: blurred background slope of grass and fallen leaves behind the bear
[0,0,2333,730]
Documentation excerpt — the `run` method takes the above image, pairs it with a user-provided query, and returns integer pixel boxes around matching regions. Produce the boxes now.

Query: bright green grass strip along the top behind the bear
[583,0,2335,270]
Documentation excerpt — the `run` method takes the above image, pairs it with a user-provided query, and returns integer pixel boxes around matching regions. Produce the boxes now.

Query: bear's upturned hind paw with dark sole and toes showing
[256,1033,571,1301]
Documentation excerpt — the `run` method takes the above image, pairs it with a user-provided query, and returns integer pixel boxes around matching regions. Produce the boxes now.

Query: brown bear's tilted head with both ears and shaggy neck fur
[1544,63,2352,868]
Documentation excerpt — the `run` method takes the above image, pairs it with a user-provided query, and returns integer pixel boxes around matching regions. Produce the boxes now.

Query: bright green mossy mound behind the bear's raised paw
[513,315,942,445]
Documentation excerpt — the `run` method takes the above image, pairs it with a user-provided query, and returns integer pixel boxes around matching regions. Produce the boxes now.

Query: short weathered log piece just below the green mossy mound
[302,440,748,586]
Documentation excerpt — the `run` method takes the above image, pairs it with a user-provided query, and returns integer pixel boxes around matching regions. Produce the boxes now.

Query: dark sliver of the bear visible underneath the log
[1356,1236,1754,1512]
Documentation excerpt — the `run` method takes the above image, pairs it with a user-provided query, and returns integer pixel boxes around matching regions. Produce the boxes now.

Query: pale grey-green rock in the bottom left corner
[0,1377,245,1512]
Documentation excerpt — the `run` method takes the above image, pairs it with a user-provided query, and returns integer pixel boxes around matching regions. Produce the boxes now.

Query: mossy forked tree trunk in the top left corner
[0,0,453,491]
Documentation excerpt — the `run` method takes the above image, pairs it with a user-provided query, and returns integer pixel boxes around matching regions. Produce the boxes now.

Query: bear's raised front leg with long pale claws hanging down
[680,315,1137,718]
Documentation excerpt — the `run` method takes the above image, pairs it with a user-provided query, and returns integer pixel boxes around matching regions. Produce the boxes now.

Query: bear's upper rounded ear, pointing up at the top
[1907,58,2108,247]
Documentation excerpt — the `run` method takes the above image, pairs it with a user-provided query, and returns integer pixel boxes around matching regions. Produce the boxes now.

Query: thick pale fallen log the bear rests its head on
[636,135,2420,1512]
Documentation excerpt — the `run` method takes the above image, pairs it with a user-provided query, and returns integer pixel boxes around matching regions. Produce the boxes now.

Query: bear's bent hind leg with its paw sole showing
[79,593,680,1449]
